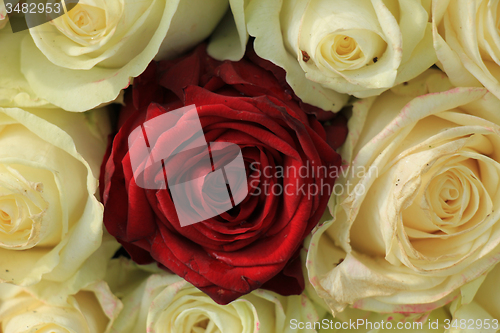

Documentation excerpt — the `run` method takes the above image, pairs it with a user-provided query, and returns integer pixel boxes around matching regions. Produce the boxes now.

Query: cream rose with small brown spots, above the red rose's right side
[229,0,437,111]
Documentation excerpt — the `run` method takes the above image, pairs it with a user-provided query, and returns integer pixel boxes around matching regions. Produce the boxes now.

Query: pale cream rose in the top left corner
[21,0,227,111]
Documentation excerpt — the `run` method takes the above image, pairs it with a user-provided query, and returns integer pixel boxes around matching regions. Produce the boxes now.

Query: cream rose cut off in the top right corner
[432,0,500,98]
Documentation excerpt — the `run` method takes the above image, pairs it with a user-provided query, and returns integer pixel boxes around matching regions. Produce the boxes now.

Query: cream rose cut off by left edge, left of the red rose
[0,108,109,286]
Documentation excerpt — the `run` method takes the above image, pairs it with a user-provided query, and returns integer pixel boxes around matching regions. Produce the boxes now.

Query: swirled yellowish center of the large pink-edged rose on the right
[403,130,500,267]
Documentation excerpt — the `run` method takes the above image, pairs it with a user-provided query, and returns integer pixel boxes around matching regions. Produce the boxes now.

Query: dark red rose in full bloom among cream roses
[101,45,346,304]
